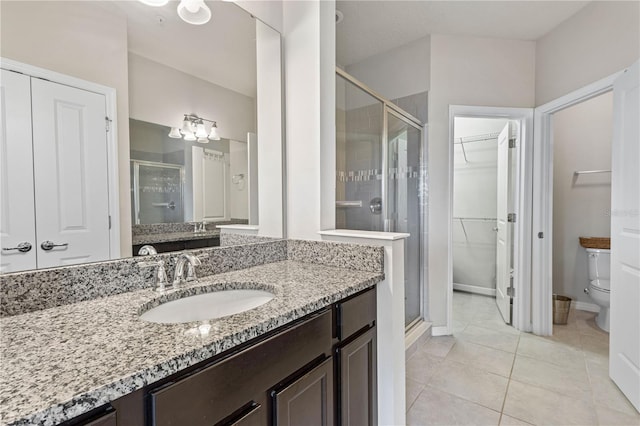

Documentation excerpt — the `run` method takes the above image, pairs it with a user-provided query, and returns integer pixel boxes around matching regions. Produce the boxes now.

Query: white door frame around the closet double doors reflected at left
[0,57,121,259]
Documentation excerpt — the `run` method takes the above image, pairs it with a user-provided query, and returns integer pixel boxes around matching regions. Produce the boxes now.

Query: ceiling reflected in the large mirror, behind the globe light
[106,1,256,98]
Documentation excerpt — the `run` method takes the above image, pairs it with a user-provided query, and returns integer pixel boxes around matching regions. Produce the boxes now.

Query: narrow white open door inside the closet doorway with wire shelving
[496,123,511,323]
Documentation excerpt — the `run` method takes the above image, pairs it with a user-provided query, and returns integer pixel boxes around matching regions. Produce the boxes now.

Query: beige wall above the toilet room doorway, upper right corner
[536,1,640,105]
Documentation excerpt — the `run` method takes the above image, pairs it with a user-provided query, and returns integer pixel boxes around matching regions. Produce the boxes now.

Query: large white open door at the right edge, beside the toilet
[609,62,640,411]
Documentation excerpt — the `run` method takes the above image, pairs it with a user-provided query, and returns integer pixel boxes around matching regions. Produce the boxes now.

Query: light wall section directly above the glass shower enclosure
[346,37,431,99]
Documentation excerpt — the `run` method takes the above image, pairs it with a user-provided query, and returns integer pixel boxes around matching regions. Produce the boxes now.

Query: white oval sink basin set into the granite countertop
[140,289,275,324]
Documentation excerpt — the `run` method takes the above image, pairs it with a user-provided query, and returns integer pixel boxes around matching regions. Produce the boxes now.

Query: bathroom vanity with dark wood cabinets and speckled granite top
[0,240,384,425]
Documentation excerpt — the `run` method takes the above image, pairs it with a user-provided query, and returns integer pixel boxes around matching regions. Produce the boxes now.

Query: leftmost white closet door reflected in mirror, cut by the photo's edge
[0,70,37,272]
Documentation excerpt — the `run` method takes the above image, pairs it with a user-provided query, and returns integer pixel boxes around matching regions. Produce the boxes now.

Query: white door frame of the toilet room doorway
[531,70,624,336]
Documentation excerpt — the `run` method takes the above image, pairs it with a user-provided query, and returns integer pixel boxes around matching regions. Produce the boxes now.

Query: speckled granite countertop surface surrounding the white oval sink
[0,260,384,425]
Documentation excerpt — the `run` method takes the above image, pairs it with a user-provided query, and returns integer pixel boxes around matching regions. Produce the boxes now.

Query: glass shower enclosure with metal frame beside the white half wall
[336,70,426,329]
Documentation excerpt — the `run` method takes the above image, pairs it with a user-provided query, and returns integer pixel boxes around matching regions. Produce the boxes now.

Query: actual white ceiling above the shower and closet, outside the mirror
[336,0,589,66]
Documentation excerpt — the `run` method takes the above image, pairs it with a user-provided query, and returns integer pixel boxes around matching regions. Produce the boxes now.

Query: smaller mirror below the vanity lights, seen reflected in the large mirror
[129,119,250,225]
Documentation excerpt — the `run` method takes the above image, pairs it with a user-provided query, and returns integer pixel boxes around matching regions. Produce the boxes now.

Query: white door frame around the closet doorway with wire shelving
[444,105,534,335]
